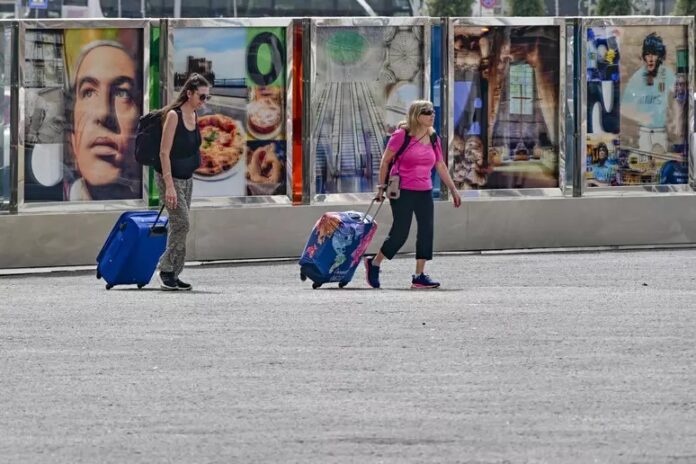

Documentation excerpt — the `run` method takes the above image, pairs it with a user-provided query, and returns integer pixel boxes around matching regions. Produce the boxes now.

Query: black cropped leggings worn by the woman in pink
[380,189,434,260]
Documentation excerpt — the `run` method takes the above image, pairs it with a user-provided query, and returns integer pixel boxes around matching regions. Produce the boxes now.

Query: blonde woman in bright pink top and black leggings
[365,100,462,288]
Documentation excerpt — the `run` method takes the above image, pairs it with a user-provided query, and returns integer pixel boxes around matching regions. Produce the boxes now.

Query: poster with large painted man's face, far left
[23,28,143,202]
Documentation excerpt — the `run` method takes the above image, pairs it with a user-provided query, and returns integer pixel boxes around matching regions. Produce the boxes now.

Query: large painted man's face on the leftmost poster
[70,45,140,186]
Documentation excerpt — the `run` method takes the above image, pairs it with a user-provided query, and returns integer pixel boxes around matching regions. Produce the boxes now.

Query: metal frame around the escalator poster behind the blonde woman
[304,17,432,203]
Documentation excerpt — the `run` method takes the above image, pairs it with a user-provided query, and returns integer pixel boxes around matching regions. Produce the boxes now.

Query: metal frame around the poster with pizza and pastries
[165,18,295,207]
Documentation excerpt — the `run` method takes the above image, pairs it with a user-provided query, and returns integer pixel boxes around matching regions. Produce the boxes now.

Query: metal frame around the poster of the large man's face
[12,19,150,212]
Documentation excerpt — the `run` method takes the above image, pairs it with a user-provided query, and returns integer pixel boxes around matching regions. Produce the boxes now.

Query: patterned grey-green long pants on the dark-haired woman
[156,173,193,278]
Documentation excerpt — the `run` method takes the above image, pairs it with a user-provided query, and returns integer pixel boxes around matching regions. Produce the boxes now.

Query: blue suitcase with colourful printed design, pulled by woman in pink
[300,200,382,289]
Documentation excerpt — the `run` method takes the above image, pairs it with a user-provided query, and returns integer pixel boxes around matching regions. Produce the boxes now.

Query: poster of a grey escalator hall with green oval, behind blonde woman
[311,26,424,194]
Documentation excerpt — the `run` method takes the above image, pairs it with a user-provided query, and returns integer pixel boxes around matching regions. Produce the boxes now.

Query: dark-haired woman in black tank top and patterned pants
[157,74,210,290]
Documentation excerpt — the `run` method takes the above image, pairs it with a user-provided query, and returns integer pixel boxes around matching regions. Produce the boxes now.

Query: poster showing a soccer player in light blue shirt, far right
[585,26,689,187]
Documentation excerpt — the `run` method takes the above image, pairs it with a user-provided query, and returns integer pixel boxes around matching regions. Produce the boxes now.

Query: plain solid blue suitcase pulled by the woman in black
[97,207,168,290]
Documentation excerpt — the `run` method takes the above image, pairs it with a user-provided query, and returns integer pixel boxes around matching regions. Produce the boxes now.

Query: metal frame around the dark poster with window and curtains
[447,17,567,199]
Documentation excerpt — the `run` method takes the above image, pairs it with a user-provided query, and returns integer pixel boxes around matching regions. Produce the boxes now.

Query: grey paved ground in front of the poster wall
[0,250,696,463]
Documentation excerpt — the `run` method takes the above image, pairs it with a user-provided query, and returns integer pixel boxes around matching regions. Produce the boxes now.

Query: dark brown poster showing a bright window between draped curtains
[450,26,560,190]
